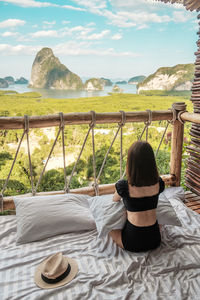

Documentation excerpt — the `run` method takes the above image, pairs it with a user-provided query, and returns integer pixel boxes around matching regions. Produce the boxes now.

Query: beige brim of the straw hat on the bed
[34,256,78,289]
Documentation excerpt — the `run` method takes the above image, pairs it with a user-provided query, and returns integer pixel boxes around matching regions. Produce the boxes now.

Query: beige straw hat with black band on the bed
[34,252,78,289]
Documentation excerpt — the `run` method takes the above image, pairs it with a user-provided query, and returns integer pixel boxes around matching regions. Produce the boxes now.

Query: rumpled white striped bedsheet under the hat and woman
[0,200,200,300]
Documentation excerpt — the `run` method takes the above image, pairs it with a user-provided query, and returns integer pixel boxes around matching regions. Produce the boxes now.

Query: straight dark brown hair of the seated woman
[126,141,159,186]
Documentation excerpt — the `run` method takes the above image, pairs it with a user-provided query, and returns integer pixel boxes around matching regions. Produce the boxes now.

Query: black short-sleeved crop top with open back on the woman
[115,177,165,212]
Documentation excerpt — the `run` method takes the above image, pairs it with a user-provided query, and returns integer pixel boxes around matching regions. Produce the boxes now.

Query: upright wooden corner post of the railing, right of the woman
[170,102,186,186]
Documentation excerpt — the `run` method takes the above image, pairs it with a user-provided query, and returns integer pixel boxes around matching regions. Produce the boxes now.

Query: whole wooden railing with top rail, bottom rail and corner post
[0,102,200,210]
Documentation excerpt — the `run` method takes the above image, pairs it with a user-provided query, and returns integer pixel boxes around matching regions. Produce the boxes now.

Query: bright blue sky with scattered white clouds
[0,0,199,80]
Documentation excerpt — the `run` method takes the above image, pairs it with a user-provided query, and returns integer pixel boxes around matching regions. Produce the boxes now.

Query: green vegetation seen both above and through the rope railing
[0,91,193,199]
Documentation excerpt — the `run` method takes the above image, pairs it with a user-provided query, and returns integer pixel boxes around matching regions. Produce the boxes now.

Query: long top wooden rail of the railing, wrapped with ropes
[0,110,173,130]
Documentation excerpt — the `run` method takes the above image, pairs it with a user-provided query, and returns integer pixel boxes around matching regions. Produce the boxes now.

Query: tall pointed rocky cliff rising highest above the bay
[30,48,83,90]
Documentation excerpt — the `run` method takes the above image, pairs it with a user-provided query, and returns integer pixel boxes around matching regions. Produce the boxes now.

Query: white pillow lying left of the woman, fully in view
[14,194,96,244]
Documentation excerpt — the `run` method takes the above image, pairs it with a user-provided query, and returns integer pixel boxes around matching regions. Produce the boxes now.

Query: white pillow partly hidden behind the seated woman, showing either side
[88,189,181,237]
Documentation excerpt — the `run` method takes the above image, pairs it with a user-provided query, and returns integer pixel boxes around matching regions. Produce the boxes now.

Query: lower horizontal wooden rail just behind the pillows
[4,174,175,210]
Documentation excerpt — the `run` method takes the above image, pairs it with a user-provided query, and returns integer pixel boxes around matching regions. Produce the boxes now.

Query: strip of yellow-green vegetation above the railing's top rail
[0,91,193,116]
